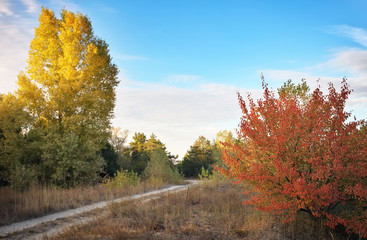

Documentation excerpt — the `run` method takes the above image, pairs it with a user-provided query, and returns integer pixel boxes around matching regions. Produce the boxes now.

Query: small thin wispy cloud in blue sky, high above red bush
[329,25,367,47]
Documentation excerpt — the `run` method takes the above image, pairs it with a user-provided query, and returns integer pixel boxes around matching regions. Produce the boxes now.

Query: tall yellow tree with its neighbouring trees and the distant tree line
[0,8,233,190]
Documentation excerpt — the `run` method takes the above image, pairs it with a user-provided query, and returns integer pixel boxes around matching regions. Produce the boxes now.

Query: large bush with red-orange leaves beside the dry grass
[219,79,367,237]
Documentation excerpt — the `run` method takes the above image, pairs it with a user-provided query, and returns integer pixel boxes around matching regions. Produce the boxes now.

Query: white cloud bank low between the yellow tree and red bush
[113,81,257,158]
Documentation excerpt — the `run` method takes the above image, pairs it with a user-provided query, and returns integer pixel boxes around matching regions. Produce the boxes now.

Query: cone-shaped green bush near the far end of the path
[143,149,182,184]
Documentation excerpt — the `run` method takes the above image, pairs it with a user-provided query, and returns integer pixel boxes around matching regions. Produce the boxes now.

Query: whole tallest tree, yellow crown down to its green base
[17,8,118,186]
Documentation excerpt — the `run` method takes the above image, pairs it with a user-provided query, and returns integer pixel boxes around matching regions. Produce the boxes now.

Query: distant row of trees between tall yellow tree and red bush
[102,129,237,177]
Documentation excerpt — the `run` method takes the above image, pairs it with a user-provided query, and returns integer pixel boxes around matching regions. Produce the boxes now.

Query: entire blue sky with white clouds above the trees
[0,0,367,158]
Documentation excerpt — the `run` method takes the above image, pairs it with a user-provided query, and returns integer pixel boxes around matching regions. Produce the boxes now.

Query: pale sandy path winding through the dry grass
[0,180,198,239]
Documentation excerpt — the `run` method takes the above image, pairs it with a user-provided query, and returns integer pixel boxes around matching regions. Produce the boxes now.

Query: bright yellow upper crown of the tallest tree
[17,8,118,141]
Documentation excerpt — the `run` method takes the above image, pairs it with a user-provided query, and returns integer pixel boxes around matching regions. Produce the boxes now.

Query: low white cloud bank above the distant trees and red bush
[114,38,367,158]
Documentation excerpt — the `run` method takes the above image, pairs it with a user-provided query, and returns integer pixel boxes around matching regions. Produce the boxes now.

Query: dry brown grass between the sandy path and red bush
[52,182,346,240]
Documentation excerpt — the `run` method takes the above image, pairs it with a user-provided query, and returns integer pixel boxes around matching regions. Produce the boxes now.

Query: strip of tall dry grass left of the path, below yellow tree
[0,182,164,226]
